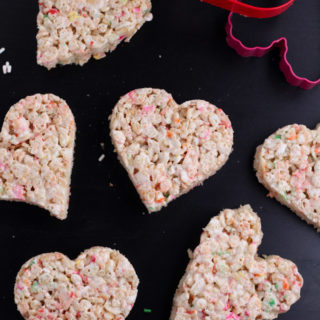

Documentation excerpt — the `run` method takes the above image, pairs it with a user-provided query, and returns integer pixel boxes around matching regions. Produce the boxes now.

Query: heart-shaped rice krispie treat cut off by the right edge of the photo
[254,124,320,231]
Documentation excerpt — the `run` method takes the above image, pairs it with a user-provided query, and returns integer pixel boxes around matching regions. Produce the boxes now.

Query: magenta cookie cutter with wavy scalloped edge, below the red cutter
[226,12,320,90]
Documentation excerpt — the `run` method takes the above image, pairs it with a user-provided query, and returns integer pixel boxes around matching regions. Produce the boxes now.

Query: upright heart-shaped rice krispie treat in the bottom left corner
[14,247,139,320]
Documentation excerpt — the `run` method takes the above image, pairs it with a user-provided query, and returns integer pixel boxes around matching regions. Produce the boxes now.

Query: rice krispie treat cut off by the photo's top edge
[37,0,152,70]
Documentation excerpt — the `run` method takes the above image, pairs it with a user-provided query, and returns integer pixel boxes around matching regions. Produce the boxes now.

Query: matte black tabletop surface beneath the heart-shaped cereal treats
[0,0,320,320]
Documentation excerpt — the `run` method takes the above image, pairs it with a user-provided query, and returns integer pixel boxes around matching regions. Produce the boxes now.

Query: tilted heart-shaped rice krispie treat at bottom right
[170,205,303,320]
